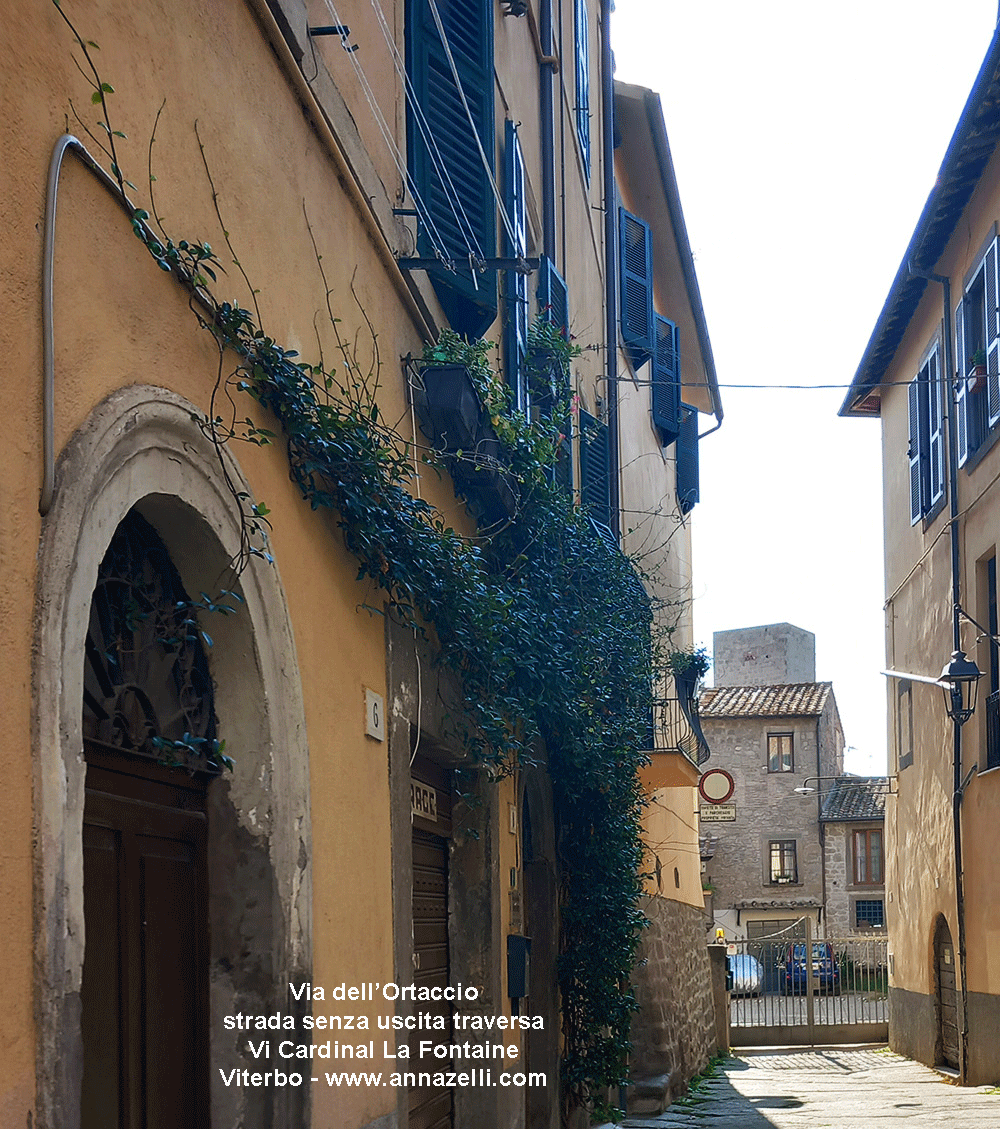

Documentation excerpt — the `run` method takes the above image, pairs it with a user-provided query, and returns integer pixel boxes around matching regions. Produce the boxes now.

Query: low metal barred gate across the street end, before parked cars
[728,918,889,1047]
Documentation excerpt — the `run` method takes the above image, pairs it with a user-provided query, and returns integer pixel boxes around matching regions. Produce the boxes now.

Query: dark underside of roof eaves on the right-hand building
[839,26,1000,417]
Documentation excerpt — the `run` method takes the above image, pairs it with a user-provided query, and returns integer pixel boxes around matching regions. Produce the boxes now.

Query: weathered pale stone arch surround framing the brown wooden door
[34,386,312,1129]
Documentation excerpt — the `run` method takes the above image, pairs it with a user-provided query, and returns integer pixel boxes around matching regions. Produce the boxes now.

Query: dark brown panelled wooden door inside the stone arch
[81,754,209,1129]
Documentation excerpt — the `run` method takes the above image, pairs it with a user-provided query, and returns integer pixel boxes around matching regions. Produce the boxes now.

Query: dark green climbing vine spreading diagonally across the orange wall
[56,5,672,1109]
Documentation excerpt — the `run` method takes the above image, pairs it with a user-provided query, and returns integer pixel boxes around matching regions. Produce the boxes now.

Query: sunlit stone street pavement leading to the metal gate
[624,1047,1000,1129]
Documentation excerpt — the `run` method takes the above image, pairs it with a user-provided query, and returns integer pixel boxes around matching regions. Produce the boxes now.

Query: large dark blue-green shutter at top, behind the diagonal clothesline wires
[406,0,497,336]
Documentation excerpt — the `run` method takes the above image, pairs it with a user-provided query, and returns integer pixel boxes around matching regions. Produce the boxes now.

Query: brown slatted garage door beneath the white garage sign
[409,828,456,1129]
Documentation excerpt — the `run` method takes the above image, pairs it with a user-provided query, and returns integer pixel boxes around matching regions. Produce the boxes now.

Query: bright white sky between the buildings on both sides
[612,0,998,772]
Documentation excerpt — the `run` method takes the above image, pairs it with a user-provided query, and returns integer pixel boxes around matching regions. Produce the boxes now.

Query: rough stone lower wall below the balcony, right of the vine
[631,896,716,1096]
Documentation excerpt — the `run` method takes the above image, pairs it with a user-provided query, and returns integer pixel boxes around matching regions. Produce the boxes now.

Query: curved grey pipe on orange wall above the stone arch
[38,133,135,517]
